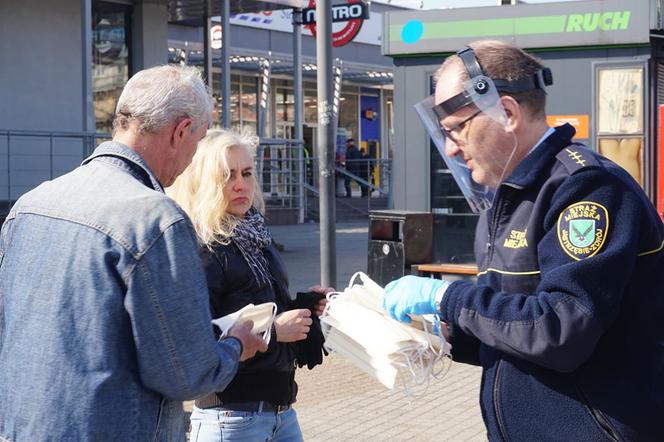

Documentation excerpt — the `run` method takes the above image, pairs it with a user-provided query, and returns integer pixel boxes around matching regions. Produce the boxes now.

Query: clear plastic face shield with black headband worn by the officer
[415,48,553,213]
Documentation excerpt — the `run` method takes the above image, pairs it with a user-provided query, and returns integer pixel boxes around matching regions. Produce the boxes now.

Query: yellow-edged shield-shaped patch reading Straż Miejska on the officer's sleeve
[558,201,609,261]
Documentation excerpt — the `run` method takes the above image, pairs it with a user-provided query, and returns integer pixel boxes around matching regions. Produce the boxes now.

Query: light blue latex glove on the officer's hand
[383,275,450,323]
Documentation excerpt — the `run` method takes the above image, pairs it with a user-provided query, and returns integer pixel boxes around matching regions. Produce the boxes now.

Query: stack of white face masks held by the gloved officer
[321,273,451,393]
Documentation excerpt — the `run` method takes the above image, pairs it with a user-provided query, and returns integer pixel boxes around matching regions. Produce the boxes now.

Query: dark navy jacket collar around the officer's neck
[503,123,576,188]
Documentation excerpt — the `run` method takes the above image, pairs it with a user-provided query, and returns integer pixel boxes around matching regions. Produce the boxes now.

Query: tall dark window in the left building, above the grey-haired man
[92,2,131,132]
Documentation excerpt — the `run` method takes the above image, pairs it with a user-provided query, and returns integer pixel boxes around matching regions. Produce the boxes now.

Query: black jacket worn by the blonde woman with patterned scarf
[201,243,297,405]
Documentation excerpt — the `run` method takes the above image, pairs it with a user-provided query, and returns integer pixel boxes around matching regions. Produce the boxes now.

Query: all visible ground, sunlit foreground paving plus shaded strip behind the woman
[184,223,487,442]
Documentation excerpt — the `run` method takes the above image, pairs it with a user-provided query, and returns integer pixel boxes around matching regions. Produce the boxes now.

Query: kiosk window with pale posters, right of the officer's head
[596,66,644,186]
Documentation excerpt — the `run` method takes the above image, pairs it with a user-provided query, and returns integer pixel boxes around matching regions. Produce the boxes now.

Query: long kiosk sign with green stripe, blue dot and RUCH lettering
[383,0,658,56]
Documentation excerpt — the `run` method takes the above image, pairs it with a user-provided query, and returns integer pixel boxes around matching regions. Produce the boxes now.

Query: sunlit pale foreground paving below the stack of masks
[295,354,486,442]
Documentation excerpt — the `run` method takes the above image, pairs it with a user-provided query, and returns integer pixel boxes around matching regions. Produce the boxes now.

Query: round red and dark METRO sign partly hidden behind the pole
[302,0,369,48]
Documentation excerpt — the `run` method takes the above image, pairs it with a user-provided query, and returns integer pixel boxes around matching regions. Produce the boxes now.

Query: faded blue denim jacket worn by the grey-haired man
[0,142,241,441]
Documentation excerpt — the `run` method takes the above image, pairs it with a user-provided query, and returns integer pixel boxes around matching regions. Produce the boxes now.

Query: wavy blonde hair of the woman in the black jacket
[166,130,264,247]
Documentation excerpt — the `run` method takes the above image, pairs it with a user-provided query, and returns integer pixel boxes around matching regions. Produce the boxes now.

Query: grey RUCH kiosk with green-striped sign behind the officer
[383,0,664,263]
